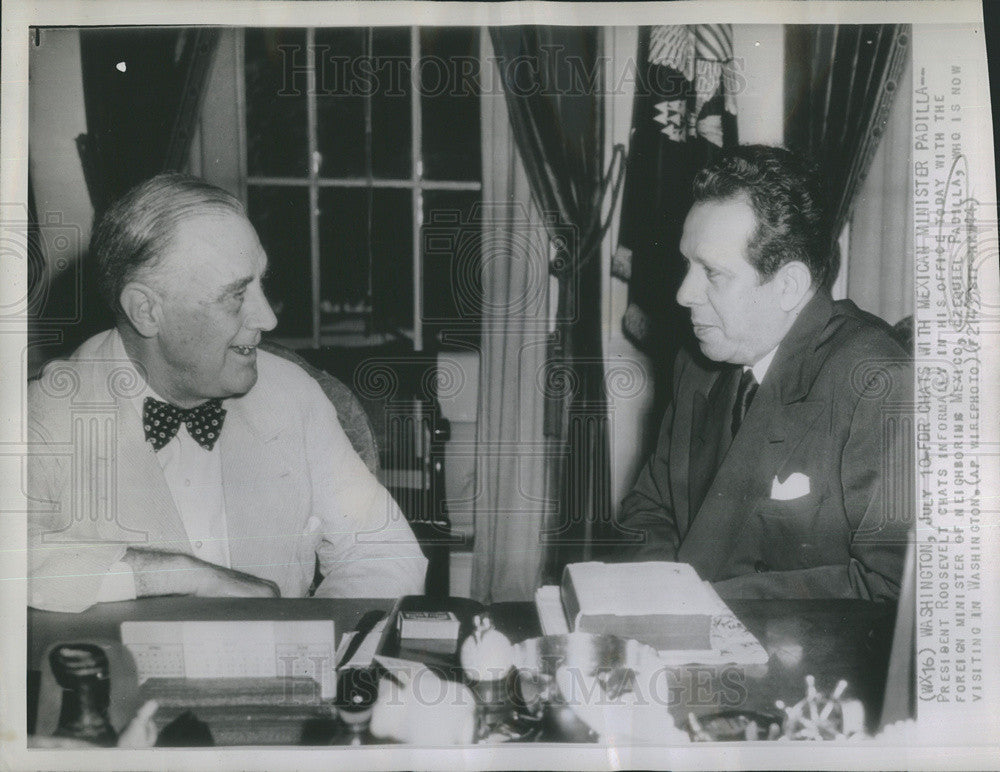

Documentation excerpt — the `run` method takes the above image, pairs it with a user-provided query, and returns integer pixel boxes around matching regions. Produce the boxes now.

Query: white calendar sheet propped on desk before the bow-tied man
[121,620,336,699]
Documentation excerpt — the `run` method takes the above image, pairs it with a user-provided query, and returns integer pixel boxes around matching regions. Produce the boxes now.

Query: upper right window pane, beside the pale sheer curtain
[420,27,482,180]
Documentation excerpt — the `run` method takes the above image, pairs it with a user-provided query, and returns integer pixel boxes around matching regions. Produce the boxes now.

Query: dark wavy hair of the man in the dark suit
[693,145,840,287]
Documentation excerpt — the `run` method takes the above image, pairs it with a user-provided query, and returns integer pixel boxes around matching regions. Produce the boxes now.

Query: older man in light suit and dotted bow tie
[27,174,426,611]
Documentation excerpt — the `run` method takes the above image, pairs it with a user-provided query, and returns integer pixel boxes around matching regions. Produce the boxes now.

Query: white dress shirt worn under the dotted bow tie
[98,333,231,602]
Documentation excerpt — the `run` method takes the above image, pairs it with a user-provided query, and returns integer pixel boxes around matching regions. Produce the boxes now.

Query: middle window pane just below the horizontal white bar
[320,188,413,332]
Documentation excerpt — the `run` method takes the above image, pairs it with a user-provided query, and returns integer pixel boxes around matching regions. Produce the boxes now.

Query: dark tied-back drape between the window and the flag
[482,26,622,579]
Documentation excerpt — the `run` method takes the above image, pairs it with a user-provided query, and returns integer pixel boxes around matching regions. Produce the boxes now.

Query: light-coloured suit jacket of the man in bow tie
[27,330,427,611]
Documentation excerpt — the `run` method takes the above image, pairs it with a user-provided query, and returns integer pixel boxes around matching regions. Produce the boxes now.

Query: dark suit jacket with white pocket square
[621,293,913,600]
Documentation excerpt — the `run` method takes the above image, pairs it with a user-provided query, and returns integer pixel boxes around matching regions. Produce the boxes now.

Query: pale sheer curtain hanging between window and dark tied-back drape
[472,52,551,602]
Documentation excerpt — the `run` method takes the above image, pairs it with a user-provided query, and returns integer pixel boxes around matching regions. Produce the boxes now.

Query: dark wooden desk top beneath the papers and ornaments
[28,597,894,731]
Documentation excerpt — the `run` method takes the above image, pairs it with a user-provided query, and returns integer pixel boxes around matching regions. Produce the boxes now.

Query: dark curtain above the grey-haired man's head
[77,28,219,216]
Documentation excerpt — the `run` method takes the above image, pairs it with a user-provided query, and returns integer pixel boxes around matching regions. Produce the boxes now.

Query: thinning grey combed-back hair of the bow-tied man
[90,172,245,317]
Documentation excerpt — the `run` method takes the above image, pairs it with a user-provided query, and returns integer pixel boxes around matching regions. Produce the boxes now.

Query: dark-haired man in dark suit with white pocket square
[621,146,913,600]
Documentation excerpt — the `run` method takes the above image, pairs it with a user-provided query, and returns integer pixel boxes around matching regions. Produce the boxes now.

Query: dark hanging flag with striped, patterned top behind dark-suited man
[612,24,739,404]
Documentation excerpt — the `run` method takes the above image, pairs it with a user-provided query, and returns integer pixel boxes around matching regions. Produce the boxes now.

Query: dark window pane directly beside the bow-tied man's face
[247,185,312,338]
